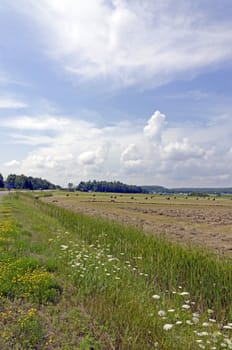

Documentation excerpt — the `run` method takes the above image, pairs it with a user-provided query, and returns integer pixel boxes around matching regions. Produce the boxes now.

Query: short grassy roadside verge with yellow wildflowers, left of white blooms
[0,198,107,350]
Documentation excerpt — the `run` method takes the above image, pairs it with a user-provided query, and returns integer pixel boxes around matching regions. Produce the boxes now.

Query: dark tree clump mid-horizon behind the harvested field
[76,180,147,193]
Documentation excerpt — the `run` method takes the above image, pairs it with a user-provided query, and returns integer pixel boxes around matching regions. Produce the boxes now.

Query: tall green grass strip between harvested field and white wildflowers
[27,194,232,320]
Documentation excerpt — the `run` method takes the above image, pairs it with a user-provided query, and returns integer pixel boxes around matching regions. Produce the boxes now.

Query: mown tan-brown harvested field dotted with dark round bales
[44,193,232,257]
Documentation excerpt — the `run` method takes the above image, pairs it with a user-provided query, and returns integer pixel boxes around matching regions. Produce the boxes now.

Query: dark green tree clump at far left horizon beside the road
[0,174,57,190]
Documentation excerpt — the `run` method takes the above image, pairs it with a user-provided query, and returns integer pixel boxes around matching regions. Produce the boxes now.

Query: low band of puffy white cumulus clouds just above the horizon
[2,111,232,186]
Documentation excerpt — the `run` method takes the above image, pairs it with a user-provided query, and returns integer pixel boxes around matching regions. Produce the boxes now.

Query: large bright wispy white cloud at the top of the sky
[12,0,232,86]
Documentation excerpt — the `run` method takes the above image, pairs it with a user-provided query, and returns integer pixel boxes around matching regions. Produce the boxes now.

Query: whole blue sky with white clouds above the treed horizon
[0,0,232,187]
